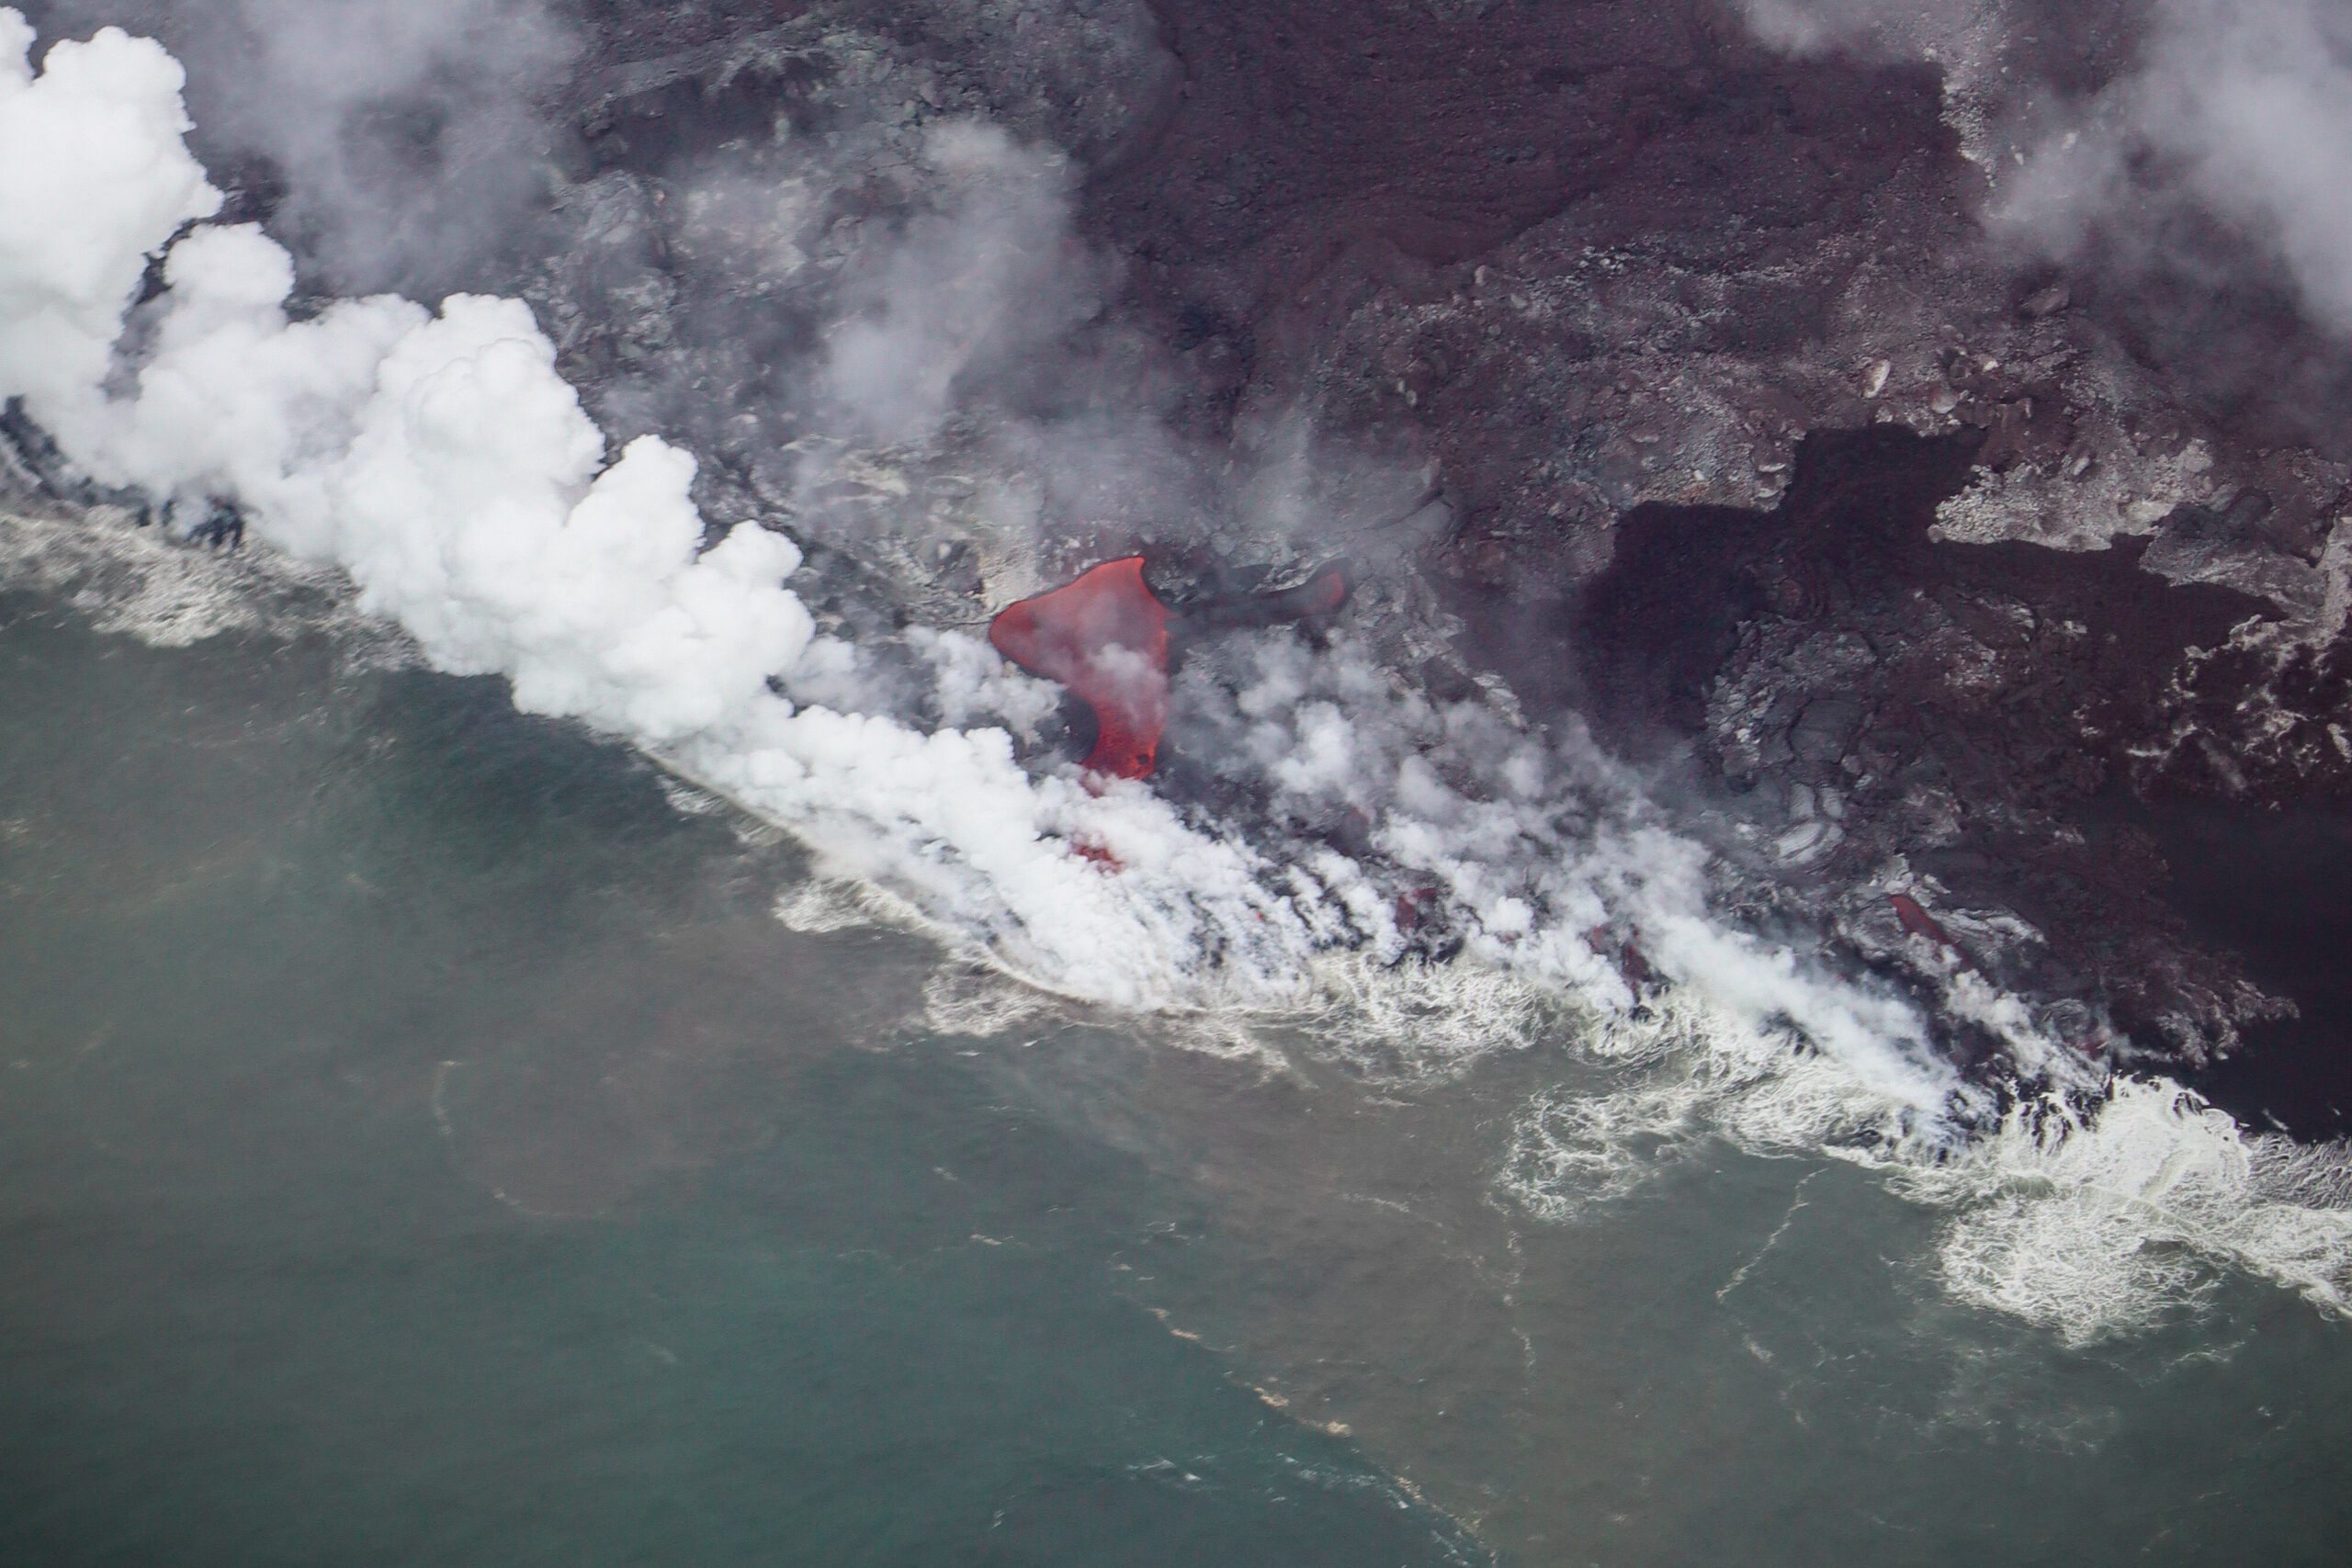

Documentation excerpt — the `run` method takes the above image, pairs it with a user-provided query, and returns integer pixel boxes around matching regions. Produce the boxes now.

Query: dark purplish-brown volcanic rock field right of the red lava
[1087,0,2352,1081]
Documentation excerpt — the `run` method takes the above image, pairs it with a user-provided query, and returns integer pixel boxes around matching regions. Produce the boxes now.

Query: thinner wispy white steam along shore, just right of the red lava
[1176,635,1954,1107]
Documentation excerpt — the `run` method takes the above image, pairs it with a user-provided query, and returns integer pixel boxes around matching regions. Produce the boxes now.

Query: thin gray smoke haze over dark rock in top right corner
[1740,0,2352,336]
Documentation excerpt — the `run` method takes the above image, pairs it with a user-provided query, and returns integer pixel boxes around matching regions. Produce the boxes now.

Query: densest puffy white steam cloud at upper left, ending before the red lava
[0,12,811,745]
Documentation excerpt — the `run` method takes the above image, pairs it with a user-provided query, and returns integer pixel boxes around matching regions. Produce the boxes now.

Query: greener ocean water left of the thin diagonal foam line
[0,600,1477,1565]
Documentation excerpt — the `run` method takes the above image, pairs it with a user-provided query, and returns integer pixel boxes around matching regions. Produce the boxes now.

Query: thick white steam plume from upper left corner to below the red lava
[0,12,1303,1020]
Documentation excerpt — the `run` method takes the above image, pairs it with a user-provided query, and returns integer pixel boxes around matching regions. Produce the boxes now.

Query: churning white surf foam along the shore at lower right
[1498,997,2352,1345]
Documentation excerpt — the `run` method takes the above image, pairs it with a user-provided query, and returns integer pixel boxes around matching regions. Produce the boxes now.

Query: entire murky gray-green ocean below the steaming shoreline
[14,588,2352,1565]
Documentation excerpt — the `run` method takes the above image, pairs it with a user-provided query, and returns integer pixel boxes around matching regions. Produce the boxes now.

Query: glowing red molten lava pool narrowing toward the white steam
[988,555,1169,778]
